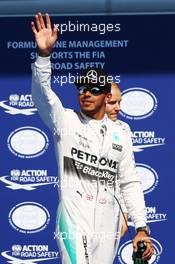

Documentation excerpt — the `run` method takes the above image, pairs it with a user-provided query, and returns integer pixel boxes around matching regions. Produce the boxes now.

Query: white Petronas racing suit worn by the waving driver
[32,57,146,264]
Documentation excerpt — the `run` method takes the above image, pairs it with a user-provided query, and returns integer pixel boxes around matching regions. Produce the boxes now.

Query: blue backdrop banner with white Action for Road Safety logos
[0,15,175,264]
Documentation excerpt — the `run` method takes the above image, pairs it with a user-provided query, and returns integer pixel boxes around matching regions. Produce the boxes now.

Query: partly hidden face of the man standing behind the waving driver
[106,87,121,121]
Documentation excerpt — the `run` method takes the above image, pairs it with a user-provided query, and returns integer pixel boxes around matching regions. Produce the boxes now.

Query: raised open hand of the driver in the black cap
[31,13,58,56]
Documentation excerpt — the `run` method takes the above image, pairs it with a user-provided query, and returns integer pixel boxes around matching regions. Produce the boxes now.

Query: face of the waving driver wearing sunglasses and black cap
[79,85,111,119]
